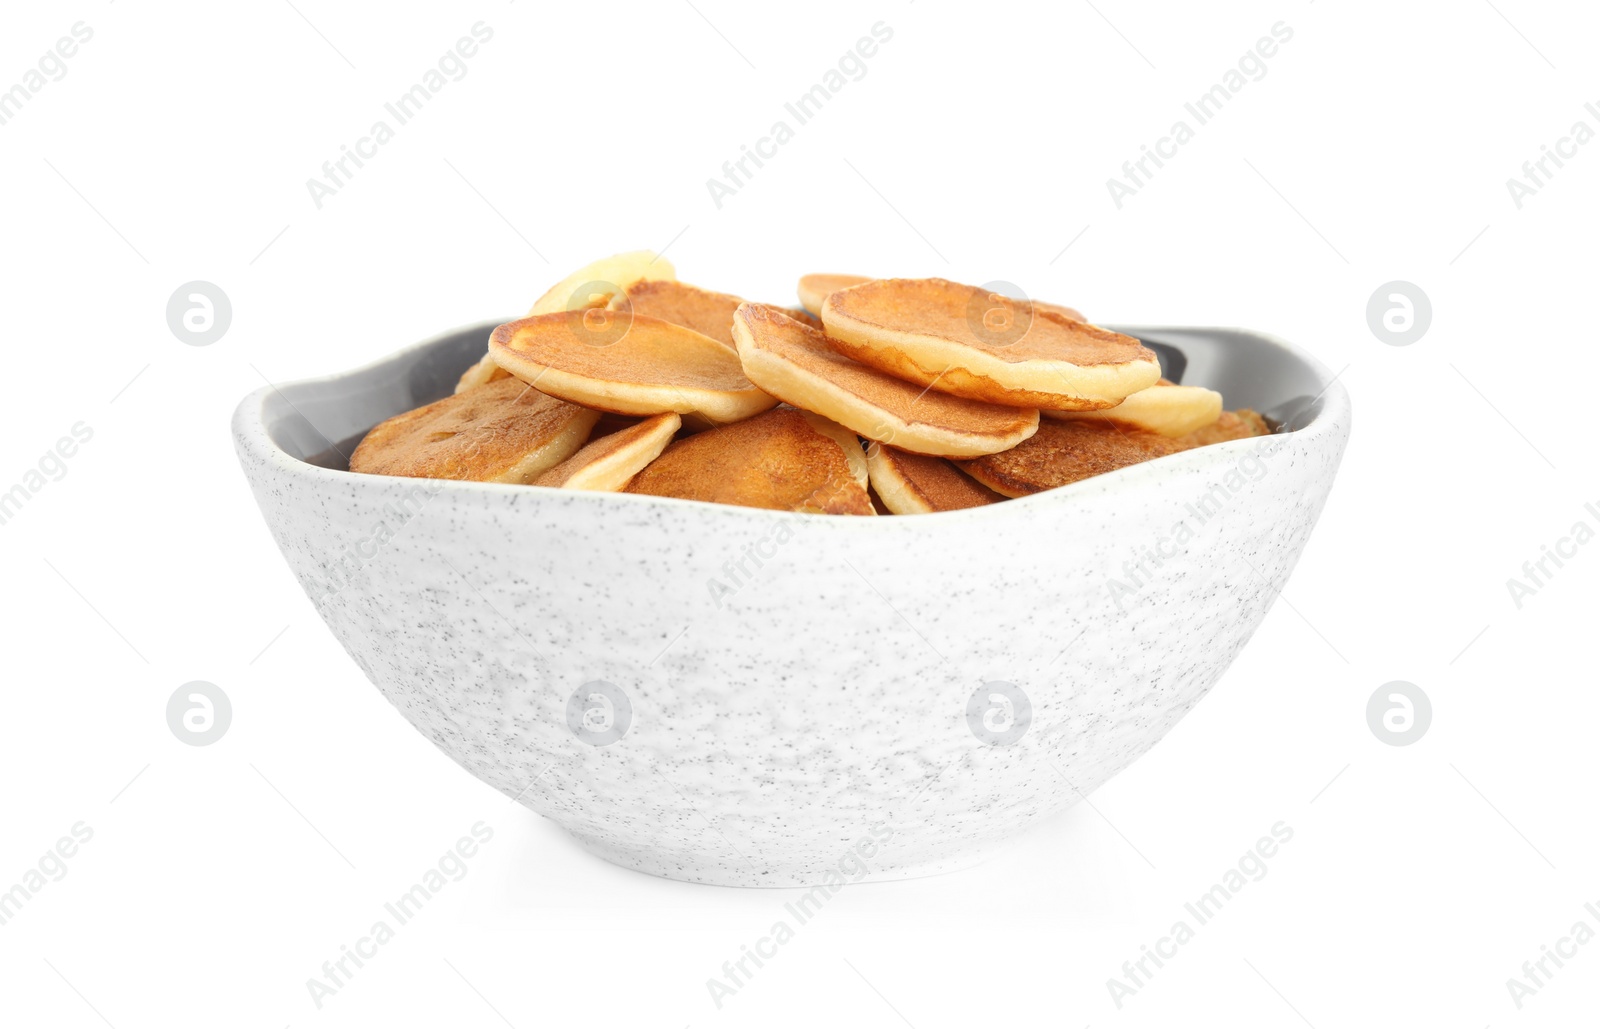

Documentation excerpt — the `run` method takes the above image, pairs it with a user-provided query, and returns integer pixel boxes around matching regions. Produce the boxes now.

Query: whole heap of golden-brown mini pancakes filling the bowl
[350,251,1270,515]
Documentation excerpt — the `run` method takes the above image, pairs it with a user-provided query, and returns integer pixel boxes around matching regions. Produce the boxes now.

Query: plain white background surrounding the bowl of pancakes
[0,0,1600,1029]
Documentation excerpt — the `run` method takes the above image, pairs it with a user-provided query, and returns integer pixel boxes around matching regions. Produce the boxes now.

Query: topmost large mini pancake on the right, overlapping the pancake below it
[822,278,1162,411]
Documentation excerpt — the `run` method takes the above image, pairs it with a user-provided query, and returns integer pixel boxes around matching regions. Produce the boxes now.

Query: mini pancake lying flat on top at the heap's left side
[490,310,778,424]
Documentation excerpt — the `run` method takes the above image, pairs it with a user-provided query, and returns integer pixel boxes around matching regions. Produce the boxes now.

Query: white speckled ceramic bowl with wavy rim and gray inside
[234,323,1350,887]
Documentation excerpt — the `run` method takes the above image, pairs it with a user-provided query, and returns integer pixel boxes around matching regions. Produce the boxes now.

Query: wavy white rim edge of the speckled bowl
[230,322,1350,531]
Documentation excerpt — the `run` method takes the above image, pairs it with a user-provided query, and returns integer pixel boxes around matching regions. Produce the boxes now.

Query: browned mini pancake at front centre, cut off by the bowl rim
[626,408,877,515]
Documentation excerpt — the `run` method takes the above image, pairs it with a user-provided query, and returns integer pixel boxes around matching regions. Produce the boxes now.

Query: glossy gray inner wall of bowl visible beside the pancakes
[262,322,1330,470]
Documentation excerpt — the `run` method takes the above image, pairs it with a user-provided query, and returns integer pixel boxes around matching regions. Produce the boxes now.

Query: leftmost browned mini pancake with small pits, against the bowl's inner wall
[350,379,600,483]
